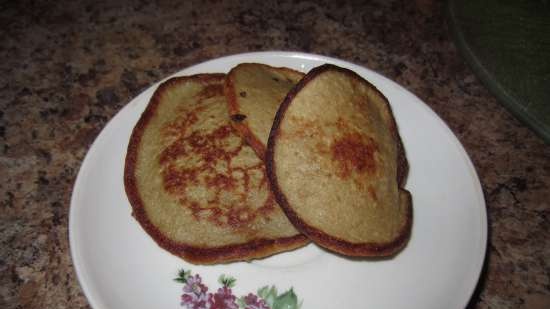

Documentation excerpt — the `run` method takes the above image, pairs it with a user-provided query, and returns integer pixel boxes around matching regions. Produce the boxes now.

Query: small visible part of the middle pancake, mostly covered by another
[224,63,304,160]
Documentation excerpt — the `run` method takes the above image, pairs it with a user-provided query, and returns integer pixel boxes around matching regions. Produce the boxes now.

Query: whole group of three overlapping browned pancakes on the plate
[124,63,412,264]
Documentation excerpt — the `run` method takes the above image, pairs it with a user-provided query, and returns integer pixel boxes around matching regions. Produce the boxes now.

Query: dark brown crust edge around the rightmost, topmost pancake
[266,64,413,257]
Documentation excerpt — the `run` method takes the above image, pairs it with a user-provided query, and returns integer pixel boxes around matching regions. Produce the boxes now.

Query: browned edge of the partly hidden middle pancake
[223,63,303,161]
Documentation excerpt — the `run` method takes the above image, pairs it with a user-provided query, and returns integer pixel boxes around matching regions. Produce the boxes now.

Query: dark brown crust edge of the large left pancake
[124,74,308,264]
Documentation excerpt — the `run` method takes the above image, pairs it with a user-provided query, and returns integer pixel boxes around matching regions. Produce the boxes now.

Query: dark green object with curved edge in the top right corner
[446,0,550,143]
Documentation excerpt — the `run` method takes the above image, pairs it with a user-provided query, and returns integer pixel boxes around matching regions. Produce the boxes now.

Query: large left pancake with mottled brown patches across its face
[124,74,307,264]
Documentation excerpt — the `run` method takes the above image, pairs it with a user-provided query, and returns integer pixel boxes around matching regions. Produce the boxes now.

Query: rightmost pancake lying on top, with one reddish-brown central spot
[266,65,412,257]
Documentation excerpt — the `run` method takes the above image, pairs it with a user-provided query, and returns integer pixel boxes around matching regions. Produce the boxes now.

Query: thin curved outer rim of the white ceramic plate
[67,50,488,308]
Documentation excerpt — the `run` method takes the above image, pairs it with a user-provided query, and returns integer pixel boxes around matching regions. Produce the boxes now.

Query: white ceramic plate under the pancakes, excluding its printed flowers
[69,52,487,309]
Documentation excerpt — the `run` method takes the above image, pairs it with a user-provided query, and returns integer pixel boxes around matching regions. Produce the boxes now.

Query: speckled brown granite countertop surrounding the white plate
[0,0,550,309]
